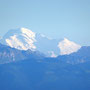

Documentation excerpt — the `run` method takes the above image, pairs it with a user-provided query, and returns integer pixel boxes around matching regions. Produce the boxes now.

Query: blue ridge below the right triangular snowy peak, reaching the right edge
[57,46,90,64]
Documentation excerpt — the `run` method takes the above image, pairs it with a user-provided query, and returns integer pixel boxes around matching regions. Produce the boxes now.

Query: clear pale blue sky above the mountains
[0,0,90,45]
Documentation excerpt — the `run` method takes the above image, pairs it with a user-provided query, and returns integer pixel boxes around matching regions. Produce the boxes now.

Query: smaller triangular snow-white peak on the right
[58,38,81,55]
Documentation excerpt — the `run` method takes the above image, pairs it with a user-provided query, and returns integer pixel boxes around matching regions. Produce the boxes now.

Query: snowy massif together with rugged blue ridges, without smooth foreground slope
[0,28,90,64]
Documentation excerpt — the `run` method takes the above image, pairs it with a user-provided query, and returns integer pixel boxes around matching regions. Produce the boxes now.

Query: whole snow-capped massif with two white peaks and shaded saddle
[1,28,81,57]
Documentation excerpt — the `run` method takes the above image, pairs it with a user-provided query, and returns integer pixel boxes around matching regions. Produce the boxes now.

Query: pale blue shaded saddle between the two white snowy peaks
[35,34,60,57]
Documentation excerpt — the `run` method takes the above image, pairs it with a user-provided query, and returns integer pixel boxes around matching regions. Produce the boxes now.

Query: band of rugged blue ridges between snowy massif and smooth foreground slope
[0,40,90,64]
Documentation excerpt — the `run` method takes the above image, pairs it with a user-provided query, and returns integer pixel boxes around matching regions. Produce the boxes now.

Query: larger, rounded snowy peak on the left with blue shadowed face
[3,28,36,50]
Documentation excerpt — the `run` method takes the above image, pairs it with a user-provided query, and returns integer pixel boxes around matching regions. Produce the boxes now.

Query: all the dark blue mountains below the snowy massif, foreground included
[0,44,90,90]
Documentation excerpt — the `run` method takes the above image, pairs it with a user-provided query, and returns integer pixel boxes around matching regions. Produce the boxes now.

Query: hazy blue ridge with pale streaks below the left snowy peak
[0,44,44,64]
